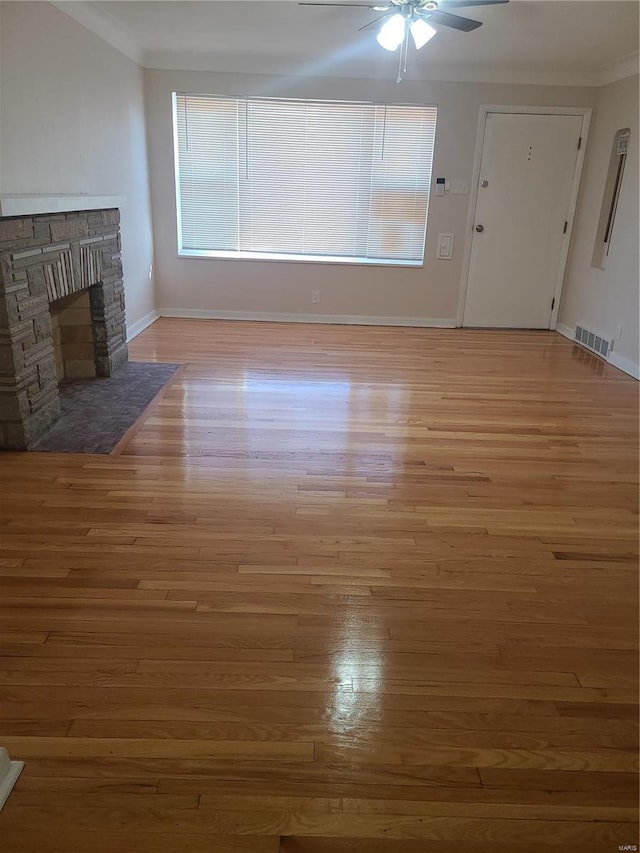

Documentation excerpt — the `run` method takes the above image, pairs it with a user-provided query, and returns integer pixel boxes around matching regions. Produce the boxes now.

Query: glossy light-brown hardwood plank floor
[0,320,638,853]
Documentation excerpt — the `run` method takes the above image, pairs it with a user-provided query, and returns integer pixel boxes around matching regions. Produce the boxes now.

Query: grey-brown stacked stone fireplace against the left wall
[0,207,127,450]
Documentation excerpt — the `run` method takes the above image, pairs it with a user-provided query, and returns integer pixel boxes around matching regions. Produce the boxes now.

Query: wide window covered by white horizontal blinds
[174,93,436,266]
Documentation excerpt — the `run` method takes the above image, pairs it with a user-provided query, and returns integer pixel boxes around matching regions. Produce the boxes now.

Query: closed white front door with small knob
[463,113,582,329]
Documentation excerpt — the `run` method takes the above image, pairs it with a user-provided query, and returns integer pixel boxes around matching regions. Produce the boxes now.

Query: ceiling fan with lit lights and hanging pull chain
[298,0,509,83]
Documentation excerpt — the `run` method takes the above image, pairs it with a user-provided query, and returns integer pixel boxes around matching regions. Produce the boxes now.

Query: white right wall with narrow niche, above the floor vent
[559,75,640,377]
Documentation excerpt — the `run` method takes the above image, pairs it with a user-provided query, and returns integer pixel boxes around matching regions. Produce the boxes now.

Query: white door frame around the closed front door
[456,104,592,329]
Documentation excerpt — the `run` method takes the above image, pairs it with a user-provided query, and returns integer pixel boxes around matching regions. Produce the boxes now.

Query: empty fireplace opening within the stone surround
[49,290,97,383]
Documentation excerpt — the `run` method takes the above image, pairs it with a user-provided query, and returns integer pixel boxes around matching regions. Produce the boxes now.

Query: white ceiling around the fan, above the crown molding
[60,0,640,82]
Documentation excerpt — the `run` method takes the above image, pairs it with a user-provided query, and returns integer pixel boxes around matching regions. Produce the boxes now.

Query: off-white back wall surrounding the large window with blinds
[145,70,595,325]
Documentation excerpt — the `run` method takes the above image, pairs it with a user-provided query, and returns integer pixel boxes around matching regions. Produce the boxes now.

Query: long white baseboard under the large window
[159,308,456,329]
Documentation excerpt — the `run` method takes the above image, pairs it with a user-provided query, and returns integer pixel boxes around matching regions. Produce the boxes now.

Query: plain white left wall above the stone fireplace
[0,2,154,329]
